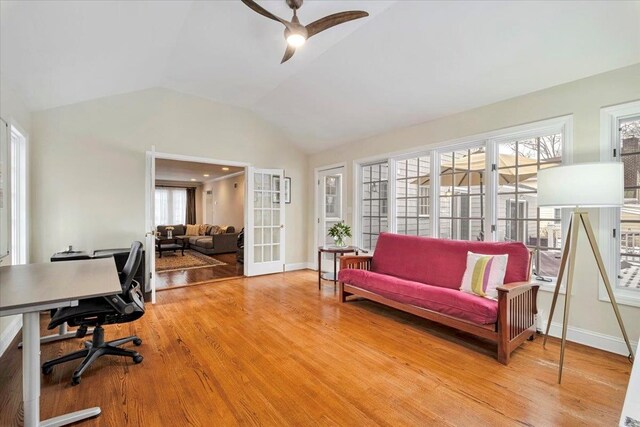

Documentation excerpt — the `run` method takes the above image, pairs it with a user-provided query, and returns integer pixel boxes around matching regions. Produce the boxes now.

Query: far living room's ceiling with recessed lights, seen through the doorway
[156,159,244,184]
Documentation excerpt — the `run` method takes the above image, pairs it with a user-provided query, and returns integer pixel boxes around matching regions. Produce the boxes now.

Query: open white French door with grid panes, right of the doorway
[245,168,285,276]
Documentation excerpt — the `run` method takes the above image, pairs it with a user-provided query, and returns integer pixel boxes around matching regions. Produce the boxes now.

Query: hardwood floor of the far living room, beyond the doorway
[156,253,244,290]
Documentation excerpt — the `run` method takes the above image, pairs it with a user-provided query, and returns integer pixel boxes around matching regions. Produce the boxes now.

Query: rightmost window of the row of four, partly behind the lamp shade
[496,133,562,277]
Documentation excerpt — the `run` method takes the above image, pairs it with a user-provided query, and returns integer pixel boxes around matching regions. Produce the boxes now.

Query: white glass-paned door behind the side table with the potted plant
[317,167,344,271]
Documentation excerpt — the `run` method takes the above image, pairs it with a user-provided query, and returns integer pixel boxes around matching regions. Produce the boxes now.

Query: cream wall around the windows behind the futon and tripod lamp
[307,64,640,352]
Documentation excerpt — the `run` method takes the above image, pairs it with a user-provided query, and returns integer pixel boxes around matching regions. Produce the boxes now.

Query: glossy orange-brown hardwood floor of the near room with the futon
[0,271,631,426]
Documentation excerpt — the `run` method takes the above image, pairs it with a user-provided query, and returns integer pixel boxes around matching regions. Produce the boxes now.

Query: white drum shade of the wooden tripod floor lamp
[538,162,624,208]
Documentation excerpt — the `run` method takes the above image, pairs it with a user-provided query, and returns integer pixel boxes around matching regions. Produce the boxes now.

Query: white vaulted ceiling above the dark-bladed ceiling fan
[0,0,640,152]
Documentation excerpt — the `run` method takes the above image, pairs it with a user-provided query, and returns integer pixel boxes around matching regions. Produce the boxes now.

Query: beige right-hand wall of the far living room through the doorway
[202,173,245,231]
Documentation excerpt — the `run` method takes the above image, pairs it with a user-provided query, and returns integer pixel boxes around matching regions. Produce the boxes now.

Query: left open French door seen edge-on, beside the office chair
[145,146,156,304]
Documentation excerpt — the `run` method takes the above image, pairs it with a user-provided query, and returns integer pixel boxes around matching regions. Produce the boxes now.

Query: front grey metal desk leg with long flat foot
[22,311,100,427]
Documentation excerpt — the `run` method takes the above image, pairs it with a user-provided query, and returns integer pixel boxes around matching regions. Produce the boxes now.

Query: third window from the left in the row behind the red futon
[438,146,487,240]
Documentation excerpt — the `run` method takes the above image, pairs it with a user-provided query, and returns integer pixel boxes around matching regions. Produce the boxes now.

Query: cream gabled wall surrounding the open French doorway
[31,89,307,263]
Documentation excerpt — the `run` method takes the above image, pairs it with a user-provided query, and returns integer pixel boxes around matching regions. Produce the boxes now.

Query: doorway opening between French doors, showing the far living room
[153,158,246,290]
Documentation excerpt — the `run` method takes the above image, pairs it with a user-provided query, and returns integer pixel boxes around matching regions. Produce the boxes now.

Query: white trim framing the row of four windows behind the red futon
[352,115,573,294]
